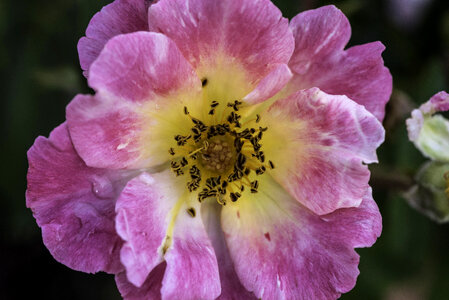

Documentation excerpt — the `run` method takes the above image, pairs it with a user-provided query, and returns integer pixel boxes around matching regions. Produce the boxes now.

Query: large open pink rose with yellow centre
[26,0,392,299]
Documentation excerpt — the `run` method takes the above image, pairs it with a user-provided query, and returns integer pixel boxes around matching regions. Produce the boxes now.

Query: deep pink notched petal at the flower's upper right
[287,6,392,120]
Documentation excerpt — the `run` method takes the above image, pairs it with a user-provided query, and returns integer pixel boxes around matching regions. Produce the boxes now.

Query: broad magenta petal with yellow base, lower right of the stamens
[221,179,381,299]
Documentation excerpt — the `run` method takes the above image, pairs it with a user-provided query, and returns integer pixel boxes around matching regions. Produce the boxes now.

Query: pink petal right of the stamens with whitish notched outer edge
[262,88,384,215]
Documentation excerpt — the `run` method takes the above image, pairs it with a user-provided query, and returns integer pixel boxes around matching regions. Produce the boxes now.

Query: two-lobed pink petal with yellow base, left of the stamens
[67,32,202,169]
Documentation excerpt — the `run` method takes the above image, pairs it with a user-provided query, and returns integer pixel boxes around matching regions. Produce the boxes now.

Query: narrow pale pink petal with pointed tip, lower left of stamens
[115,172,177,287]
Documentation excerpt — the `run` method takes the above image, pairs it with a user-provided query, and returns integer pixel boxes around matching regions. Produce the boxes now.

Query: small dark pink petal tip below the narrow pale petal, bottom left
[115,263,166,300]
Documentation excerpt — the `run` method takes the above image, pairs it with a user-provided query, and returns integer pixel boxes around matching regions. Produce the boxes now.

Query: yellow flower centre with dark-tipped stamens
[168,99,275,205]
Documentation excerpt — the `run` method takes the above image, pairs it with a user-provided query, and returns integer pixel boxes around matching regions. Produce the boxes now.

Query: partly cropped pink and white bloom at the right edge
[406,92,449,162]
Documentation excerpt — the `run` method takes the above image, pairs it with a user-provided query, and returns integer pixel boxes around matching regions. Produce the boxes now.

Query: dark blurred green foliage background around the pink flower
[0,0,449,299]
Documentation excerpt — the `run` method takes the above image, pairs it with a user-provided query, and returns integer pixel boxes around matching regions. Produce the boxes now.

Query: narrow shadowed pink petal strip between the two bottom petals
[201,199,257,300]
